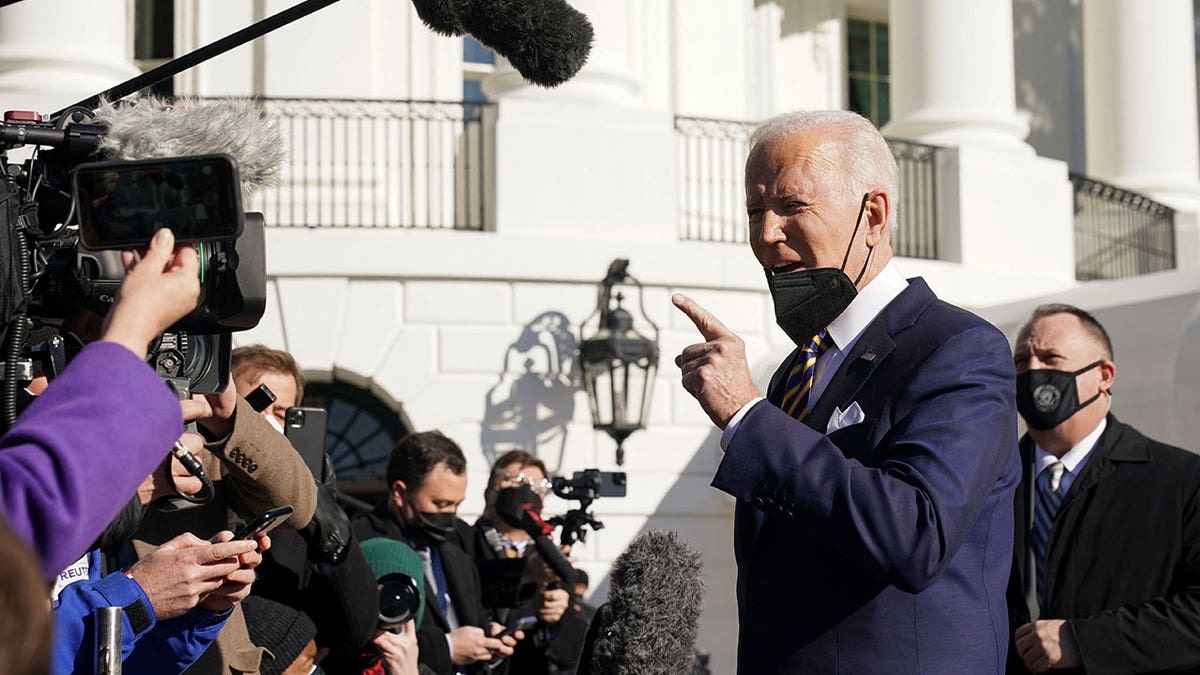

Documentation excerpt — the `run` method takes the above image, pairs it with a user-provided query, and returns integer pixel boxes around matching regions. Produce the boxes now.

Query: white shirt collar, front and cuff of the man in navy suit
[721,259,908,450]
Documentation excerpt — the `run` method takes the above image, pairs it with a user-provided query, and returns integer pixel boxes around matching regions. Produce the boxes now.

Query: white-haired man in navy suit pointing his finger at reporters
[673,112,1020,675]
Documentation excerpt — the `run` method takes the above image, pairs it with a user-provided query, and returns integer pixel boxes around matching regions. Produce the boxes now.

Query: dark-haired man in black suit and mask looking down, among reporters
[353,431,523,675]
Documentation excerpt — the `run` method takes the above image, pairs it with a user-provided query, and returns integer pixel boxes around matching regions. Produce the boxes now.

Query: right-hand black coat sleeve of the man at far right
[1068,471,1200,675]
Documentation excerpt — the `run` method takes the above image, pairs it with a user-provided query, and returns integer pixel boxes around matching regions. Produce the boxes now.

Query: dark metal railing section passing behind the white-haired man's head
[676,117,940,259]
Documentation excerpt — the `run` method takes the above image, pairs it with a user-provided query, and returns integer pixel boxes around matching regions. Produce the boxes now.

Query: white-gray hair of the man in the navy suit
[750,110,900,229]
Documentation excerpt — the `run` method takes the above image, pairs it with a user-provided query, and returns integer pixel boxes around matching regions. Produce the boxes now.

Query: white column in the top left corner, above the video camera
[0,0,138,113]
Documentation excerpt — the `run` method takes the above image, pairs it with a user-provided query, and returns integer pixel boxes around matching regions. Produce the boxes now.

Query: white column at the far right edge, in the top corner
[1084,0,1200,211]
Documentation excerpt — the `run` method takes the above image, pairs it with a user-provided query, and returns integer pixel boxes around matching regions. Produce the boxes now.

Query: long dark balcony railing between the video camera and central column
[251,98,492,229]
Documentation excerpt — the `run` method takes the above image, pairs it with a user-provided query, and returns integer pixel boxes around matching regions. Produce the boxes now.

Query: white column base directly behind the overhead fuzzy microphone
[484,0,641,106]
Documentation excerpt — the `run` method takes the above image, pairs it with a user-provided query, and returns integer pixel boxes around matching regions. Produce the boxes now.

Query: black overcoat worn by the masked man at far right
[1008,414,1200,675]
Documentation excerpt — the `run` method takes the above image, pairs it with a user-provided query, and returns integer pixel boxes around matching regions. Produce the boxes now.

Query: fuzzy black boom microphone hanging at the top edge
[412,0,594,86]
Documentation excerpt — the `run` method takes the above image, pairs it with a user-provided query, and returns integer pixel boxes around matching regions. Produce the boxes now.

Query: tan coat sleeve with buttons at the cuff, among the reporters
[204,396,317,530]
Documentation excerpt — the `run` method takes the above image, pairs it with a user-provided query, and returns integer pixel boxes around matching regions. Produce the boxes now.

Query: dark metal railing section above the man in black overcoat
[1070,174,1175,281]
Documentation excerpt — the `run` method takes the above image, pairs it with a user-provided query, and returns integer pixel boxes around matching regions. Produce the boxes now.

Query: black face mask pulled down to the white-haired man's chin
[766,193,875,347]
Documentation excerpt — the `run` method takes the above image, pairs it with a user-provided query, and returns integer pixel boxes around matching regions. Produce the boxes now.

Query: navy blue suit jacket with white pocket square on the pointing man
[713,279,1020,675]
